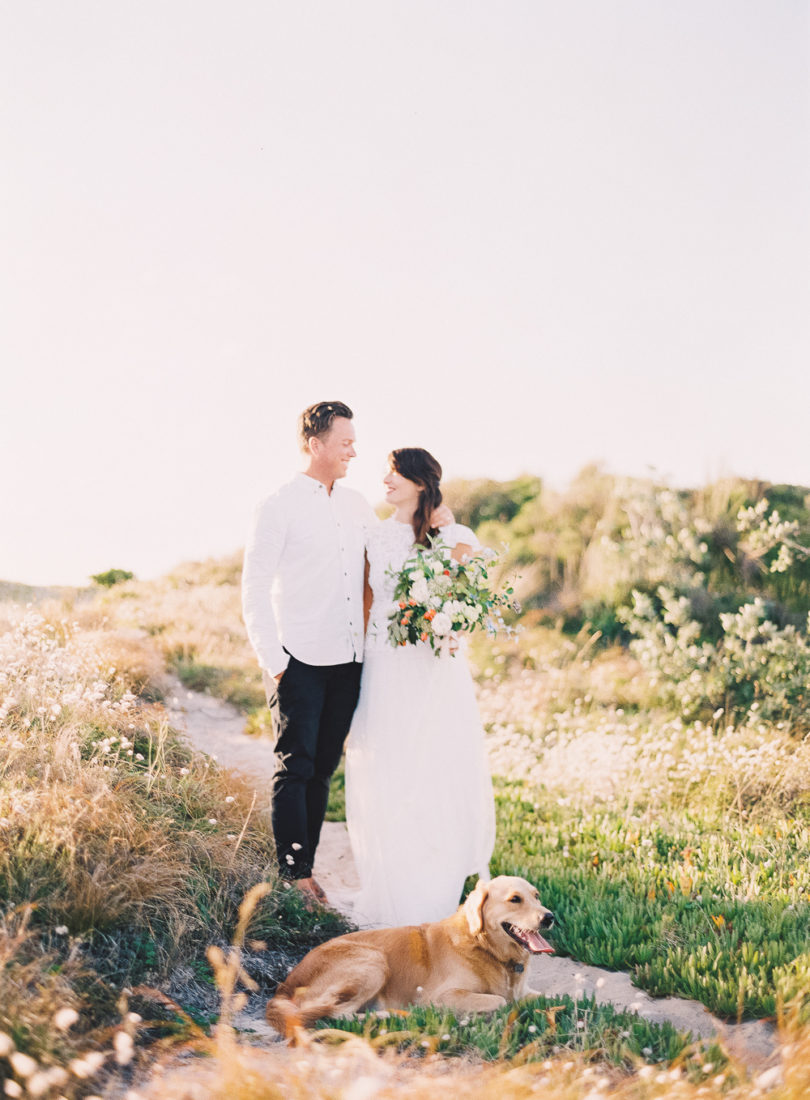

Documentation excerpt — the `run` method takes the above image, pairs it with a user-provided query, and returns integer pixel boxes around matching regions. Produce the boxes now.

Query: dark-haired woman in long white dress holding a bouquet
[346,447,495,926]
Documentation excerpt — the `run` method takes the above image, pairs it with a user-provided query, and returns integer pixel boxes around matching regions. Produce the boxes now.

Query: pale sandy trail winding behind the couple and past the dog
[167,681,776,1069]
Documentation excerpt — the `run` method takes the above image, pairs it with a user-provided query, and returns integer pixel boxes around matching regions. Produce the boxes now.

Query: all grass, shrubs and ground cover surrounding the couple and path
[0,468,810,1100]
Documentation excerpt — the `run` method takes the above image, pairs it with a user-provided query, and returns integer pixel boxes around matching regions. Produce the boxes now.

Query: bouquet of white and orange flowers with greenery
[388,542,519,653]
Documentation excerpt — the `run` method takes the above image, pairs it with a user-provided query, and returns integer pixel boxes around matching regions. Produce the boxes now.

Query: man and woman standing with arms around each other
[242,402,494,926]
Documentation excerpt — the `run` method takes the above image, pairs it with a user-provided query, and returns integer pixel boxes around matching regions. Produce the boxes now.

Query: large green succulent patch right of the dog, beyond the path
[492,784,810,1019]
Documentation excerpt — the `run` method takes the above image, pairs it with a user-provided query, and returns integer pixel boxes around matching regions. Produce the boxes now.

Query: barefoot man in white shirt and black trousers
[242,402,375,905]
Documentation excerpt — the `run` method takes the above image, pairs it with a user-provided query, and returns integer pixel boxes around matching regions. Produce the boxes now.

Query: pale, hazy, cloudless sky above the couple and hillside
[0,0,810,584]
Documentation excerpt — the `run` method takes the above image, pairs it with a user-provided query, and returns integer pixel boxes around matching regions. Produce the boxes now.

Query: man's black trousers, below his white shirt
[273,657,362,879]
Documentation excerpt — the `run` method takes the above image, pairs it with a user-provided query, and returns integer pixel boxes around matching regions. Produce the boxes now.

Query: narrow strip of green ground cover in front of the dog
[318,997,723,1067]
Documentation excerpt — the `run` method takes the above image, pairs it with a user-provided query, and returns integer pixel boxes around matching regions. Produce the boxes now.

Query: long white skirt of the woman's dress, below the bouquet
[346,639,495,927]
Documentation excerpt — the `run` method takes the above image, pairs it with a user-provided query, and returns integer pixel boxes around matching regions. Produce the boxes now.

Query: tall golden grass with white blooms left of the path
[0,604,344,1095]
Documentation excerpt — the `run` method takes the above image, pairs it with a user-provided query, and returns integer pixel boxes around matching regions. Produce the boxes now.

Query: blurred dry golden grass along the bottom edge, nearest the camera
[139,1012,810,1100]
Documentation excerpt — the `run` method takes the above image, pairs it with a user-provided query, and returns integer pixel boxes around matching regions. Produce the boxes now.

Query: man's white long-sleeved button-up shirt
[242,473,376,677]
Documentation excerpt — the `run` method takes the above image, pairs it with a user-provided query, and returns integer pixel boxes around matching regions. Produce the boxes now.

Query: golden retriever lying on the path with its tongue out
[266,875,554,1035]
